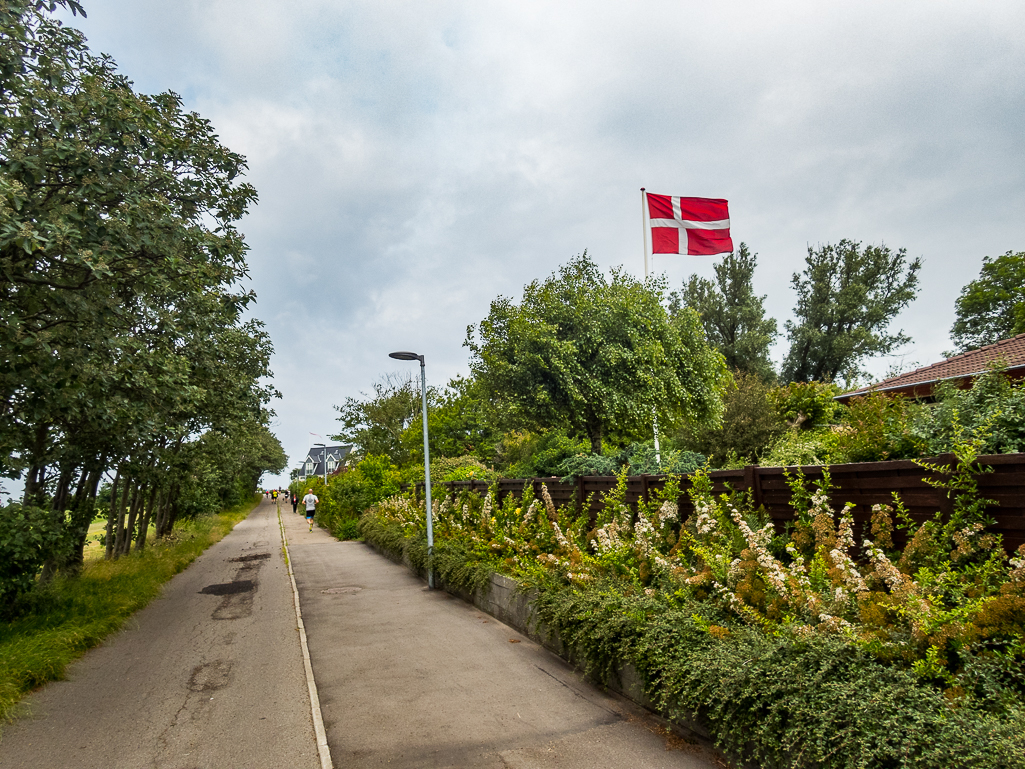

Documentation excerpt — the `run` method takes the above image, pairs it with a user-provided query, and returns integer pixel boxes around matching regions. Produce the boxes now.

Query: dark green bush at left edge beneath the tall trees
[0,502,67,613]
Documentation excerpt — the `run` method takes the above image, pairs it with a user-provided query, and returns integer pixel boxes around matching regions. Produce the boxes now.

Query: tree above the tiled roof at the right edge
[950,251,1025,353]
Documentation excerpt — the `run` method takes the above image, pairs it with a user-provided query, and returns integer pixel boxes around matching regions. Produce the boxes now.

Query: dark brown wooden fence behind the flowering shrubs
[407,454,1025,553]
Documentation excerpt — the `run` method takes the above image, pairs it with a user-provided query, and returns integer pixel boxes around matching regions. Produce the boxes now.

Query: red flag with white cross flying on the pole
[646,194,733,256]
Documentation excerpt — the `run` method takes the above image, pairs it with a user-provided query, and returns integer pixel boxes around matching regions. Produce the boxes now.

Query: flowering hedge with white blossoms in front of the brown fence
[361,436,1025,767]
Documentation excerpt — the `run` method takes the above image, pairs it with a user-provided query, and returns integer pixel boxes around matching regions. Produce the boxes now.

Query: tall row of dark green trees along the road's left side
[0,0,285,594]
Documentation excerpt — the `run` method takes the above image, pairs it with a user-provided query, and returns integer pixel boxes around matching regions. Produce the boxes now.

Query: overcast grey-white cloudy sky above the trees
[56,0,1025,478]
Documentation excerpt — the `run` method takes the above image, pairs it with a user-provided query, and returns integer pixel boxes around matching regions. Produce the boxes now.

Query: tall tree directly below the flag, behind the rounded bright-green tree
[669,243,779,380]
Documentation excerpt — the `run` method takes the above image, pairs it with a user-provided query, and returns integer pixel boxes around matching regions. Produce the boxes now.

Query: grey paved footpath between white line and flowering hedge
[281,507,723,769]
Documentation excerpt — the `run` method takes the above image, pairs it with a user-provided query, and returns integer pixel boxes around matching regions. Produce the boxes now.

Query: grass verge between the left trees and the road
[0,499,259,722]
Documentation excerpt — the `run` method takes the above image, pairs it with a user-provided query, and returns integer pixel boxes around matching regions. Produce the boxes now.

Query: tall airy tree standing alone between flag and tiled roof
[782,239,921,381]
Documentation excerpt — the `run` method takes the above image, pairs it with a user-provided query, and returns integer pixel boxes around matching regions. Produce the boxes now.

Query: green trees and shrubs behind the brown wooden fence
[335,240,1025,479]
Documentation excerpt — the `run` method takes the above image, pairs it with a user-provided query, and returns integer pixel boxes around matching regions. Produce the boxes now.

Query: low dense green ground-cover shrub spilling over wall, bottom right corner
[634,619,1025,769]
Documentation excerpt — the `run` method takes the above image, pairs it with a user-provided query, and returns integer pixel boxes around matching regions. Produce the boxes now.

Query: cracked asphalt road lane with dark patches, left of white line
[0,500,320,769]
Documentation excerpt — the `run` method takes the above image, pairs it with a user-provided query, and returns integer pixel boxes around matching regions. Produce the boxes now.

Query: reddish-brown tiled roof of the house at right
[834,334,1025,403]
